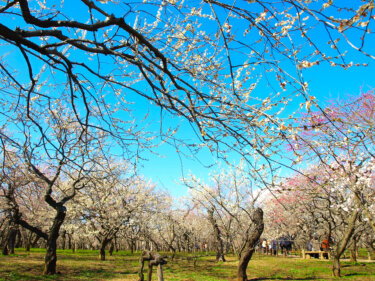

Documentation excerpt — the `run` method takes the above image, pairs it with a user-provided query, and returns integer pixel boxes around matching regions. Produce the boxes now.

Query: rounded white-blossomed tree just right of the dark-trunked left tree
[69,162,162,260]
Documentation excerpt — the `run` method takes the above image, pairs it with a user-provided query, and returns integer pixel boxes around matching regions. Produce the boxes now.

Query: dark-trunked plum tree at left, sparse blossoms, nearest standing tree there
[1,100,111,274]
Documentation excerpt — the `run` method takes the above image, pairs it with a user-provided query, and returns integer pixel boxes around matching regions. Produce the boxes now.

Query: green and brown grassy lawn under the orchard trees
[0,249,375,281]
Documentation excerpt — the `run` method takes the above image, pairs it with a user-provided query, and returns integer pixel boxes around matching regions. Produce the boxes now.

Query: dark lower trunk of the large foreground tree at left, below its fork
[43,208,66,275]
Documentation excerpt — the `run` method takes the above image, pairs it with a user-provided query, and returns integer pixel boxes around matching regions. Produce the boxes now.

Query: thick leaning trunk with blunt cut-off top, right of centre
[237,208,264,281]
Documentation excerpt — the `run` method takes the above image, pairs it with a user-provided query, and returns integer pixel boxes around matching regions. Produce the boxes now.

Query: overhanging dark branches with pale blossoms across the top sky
[0,0,374,168]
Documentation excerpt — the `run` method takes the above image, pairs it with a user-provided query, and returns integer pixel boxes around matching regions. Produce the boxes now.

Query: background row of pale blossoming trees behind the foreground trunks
[1,150,375,278]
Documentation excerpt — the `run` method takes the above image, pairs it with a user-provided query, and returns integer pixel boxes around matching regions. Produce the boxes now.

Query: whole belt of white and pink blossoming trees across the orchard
[0,91,375,280]
